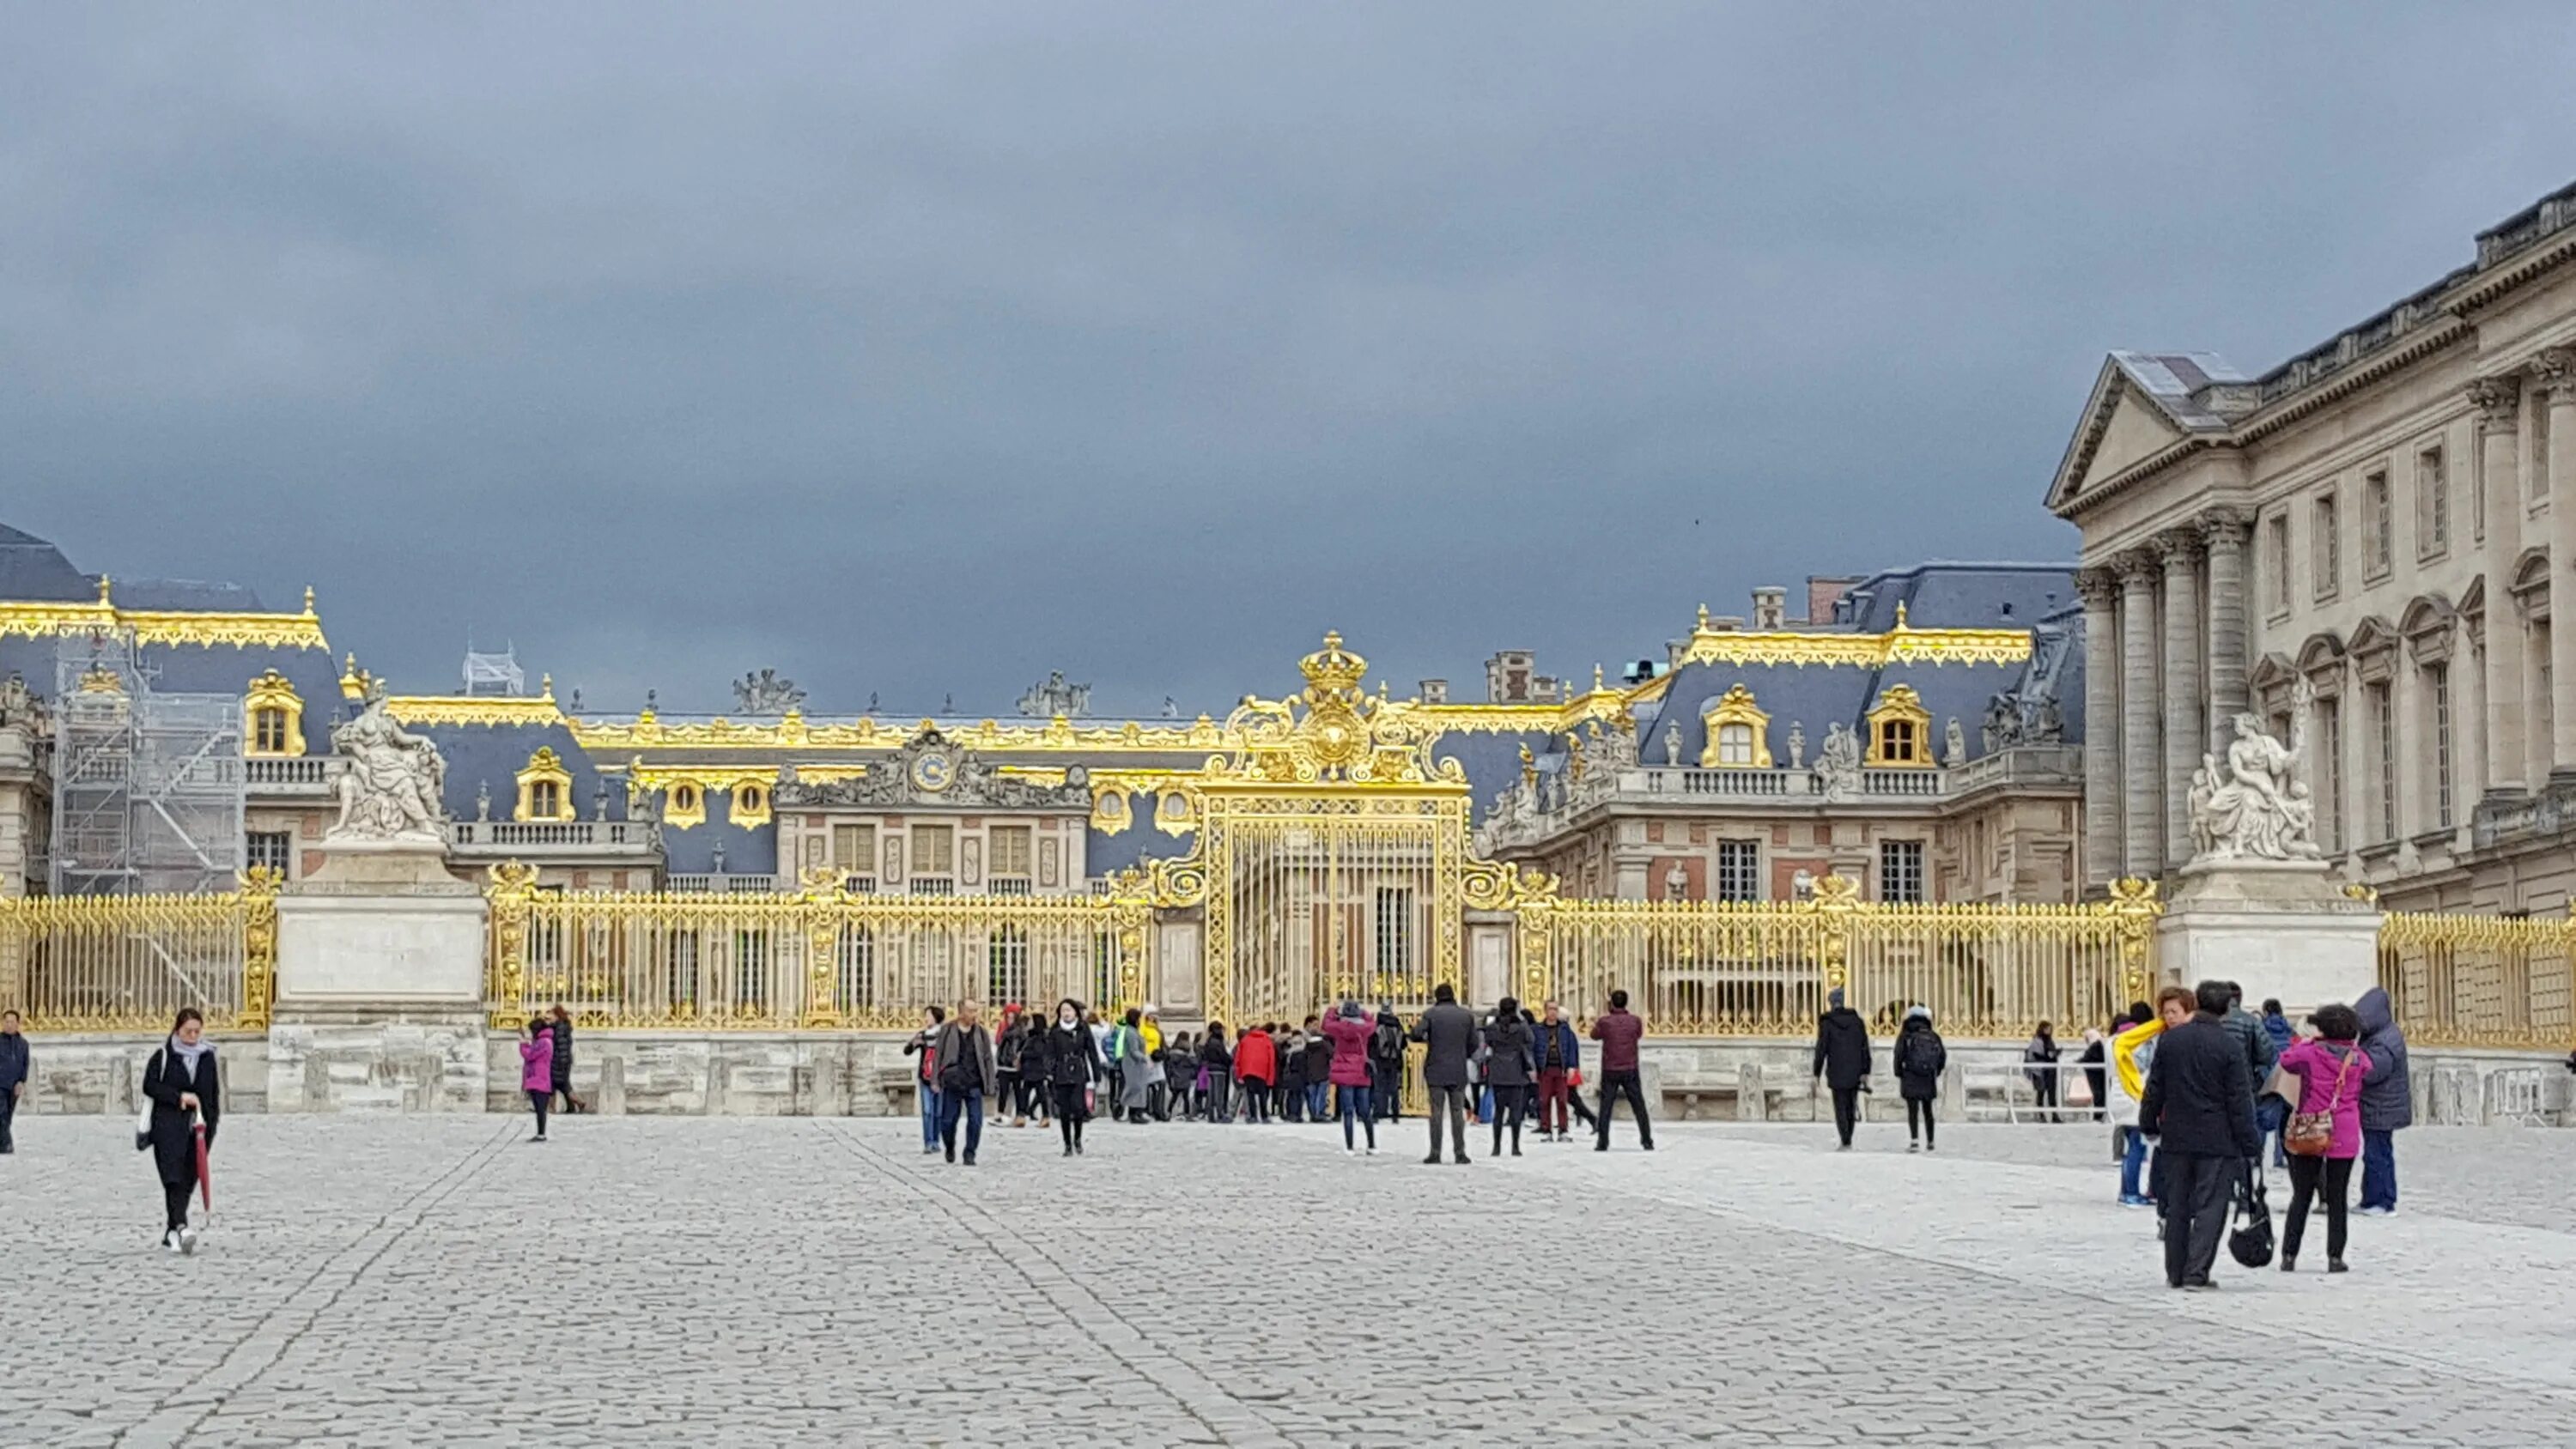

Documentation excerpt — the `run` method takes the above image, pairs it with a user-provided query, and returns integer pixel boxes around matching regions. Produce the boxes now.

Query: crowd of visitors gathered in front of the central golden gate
[896,983,1654,1166]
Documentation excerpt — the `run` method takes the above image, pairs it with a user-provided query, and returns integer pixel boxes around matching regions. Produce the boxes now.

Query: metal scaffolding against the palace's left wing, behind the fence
[52,631,247,895]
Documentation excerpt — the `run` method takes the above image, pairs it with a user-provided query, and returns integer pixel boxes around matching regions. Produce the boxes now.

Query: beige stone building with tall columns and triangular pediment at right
[2048,176,2576,913]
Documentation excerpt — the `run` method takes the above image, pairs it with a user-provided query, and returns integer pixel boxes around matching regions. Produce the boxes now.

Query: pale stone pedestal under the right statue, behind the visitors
[2156,859,2380,1019]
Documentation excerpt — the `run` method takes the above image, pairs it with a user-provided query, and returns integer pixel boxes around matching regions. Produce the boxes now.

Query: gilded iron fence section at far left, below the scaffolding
[0,867,278,1032]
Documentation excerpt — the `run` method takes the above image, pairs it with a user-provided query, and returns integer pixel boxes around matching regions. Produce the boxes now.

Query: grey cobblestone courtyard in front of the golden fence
[0,1117,2576,1446]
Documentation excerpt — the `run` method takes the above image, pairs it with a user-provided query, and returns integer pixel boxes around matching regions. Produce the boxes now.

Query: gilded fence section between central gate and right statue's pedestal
[1520,877,2161,1040]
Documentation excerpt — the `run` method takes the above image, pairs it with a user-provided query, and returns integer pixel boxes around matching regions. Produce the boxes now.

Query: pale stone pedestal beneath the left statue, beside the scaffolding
[268,839,489,1112]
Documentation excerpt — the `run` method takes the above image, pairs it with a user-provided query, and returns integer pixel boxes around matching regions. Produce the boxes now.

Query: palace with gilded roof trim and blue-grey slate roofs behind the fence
[0,519,2084,916]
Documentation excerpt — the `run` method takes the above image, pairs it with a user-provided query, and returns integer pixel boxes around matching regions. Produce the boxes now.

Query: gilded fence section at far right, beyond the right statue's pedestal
[2380,911,2576,1050]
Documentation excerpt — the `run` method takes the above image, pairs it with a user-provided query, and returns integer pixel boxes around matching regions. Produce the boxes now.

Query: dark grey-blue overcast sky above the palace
[15,0,2576,713]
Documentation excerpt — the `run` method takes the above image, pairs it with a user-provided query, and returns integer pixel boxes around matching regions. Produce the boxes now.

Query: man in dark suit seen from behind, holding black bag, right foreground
[2138,980,2262,1289]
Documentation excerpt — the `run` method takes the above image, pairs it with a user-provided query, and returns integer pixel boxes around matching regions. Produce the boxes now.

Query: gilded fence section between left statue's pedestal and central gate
[487,864,1149,1029]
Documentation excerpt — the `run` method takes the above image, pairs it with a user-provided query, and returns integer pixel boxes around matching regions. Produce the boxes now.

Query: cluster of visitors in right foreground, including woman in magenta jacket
[2107,980,2414,1289]
